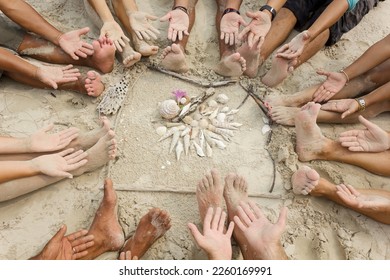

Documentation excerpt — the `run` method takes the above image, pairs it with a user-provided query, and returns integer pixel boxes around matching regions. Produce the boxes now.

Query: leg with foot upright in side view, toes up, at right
[295,102,390,176]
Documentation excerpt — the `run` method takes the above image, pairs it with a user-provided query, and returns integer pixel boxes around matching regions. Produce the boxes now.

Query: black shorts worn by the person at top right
[283,0,379,46]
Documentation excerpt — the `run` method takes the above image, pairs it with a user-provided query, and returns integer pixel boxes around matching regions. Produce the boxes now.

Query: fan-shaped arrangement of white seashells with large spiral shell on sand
[156,88,242,160]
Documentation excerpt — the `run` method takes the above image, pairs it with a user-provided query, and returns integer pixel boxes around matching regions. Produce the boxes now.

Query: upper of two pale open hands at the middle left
[27,124,79,153]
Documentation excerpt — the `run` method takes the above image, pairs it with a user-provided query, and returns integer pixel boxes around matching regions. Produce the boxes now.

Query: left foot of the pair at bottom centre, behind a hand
[196,169,223,221]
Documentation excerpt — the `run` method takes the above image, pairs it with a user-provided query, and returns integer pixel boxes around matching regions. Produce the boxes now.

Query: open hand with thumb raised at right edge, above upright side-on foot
[339,116,390,152]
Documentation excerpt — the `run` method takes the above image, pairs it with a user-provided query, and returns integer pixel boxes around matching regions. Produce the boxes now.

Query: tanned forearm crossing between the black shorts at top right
[307,0,348,41]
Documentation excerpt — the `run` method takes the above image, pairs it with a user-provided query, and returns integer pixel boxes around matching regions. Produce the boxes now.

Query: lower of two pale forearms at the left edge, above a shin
[0,161,41,183]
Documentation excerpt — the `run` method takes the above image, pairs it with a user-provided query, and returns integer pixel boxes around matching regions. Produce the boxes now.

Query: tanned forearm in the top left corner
[0,0,62,45]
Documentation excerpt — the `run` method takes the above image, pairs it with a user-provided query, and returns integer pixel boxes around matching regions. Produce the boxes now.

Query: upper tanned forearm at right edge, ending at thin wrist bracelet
[344,35,390,79]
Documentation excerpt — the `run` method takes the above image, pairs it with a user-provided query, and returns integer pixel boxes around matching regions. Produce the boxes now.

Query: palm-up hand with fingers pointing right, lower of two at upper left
[35,64,80,89]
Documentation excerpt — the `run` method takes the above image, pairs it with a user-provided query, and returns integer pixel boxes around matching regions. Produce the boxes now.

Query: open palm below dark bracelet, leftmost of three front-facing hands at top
[160,9,190,42]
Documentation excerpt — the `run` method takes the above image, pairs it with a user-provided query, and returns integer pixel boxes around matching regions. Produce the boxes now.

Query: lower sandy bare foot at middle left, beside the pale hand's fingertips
[72,130,116,176]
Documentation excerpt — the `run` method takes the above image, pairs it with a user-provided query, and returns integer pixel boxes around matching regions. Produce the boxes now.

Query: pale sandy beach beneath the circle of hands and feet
[0,0,390,260]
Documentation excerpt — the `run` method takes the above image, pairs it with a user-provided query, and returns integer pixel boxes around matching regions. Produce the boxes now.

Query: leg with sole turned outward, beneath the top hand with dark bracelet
[161,0,198,73]
